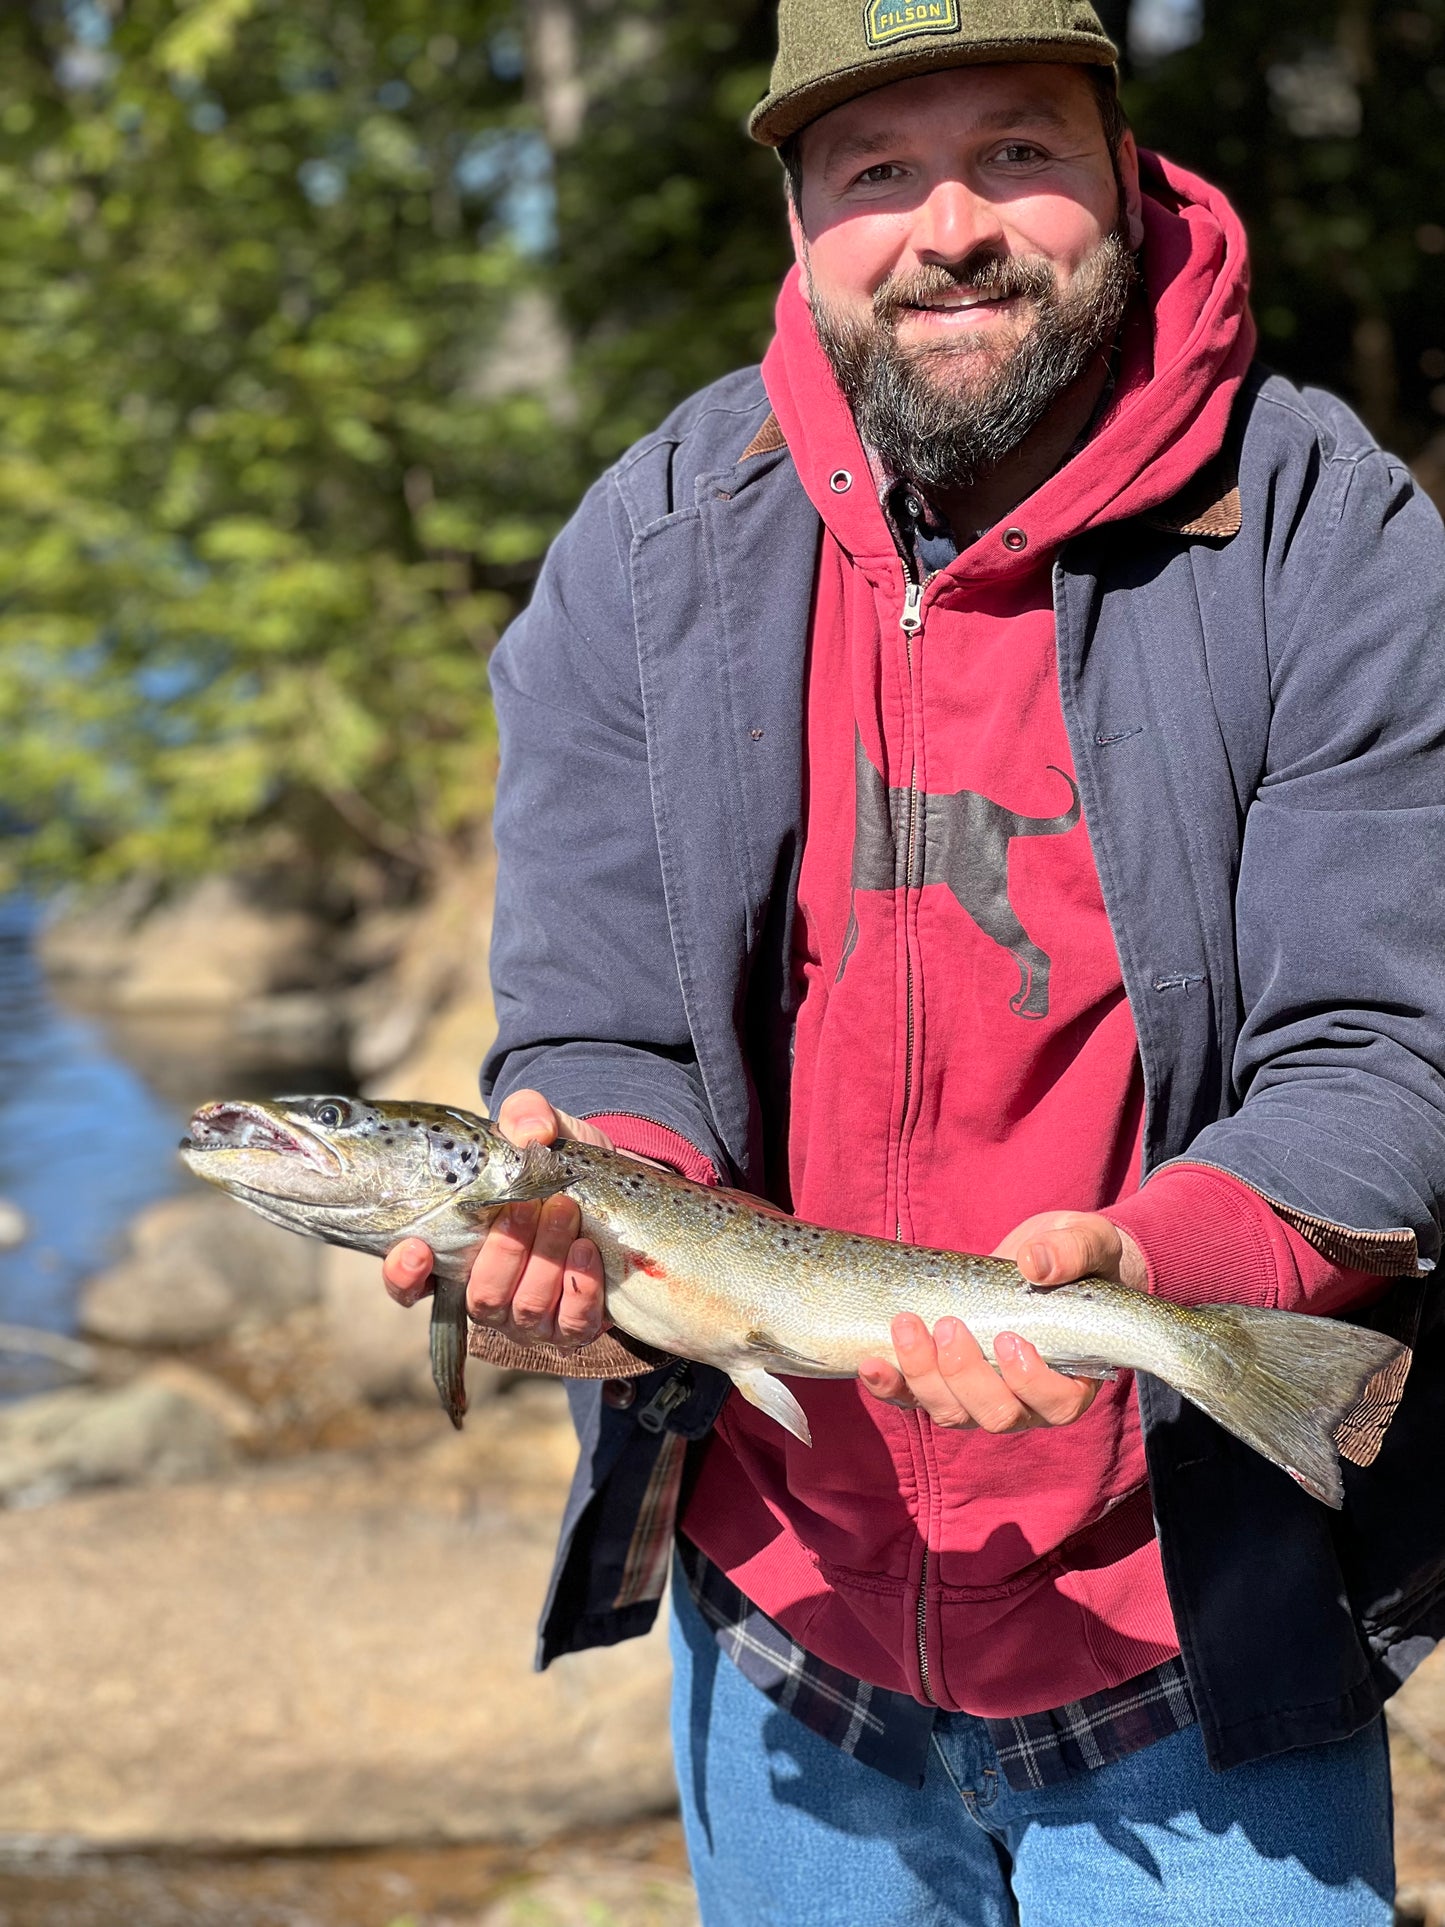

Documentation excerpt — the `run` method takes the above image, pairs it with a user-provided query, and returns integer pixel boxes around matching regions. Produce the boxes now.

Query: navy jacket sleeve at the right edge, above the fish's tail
[1187,447,1445,1272]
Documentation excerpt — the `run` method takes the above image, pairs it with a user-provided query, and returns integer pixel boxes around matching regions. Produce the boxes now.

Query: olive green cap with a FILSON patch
[748,0,1119,146]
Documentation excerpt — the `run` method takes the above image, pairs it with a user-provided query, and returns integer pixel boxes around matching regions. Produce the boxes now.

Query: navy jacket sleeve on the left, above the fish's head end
[482,476,728,1174]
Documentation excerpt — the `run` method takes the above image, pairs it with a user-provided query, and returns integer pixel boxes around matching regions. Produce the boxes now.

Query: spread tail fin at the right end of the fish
[1177,1305,1410,1511]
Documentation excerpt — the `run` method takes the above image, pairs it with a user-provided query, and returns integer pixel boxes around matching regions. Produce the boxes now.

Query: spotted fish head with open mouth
[181,1096,522,1245]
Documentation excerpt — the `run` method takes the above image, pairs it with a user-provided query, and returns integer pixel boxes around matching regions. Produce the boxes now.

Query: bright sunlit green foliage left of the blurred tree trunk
[0,0,576,875]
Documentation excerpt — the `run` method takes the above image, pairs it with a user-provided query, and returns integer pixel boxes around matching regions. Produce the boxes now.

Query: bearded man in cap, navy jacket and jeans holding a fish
[387,0,1445,1927]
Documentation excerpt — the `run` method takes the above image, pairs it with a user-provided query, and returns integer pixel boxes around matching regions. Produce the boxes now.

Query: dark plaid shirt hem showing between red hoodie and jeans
[678,1534,1195,1790]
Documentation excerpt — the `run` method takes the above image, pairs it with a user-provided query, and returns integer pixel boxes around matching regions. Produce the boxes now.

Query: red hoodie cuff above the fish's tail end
[1102,1164,1387,1314]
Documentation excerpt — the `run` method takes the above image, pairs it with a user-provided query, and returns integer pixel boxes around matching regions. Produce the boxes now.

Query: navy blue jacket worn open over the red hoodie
[484,370,1445,1767]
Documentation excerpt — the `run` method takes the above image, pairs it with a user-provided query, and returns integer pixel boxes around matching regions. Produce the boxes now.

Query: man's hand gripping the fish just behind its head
[381,1091,613,1351]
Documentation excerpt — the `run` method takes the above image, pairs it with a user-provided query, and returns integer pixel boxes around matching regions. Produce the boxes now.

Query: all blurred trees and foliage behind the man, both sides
[0,0,1445,877]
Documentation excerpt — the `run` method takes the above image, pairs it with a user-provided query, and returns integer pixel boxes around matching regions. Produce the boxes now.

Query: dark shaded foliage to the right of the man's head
[1125,0,1445,481]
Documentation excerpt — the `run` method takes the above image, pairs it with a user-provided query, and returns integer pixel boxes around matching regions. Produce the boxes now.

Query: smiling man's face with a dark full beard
[794,66,1143,488]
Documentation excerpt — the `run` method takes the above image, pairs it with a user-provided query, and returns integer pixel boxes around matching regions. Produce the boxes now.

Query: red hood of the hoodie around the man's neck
[763,152,1254,578]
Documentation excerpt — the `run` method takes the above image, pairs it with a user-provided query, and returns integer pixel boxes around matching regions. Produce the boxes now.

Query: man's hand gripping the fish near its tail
[857,1210,1148,1432]
